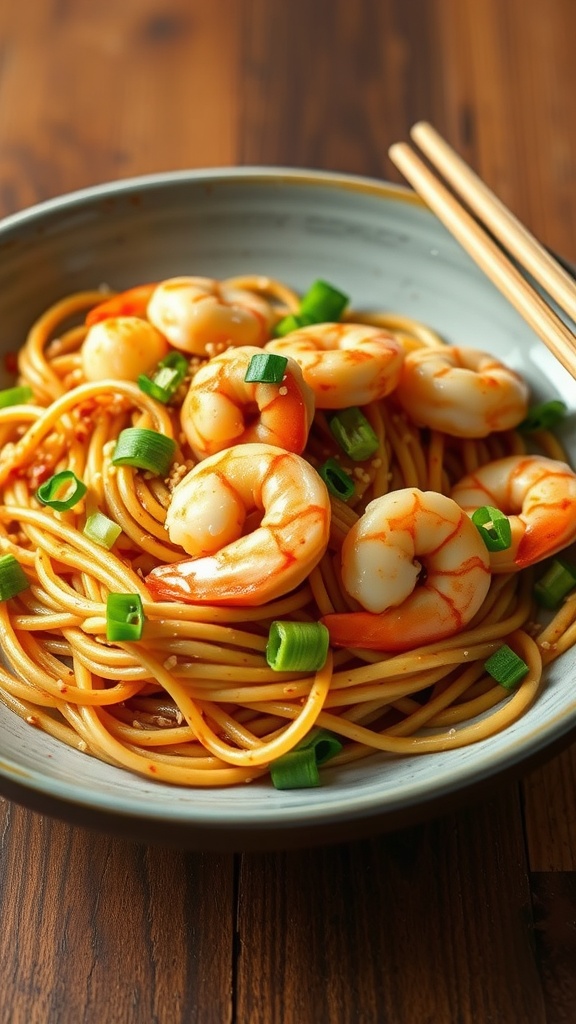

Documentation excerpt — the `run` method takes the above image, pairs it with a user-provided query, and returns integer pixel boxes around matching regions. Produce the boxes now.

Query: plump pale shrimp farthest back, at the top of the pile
[147,278,274,356]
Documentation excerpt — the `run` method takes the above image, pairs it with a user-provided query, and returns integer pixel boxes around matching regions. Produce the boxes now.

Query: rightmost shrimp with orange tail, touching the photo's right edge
[451,455,576,572]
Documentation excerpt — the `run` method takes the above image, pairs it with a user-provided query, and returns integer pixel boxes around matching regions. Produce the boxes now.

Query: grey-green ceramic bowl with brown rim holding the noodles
[0,168,576,849]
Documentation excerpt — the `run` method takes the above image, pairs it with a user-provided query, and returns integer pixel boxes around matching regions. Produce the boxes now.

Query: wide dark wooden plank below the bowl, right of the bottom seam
[238,792,546,1024]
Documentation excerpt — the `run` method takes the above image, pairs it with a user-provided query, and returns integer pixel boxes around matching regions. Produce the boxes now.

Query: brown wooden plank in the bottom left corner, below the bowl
[0,802,235,1024]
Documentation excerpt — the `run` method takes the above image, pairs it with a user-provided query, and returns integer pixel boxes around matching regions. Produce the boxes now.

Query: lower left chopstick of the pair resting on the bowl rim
[388,126,576,378]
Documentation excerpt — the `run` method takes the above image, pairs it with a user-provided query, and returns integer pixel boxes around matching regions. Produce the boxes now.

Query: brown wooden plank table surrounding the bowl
[0,0,576,1024]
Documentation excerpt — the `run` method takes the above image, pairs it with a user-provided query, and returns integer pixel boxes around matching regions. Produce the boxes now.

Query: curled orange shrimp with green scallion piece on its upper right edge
[180,345,315,459]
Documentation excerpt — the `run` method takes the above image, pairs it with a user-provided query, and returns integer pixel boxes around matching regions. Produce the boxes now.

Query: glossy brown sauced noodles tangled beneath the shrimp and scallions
[0,278,576,786]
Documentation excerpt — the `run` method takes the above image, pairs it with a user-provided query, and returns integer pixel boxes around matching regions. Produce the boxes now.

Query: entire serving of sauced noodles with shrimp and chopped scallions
[0,266,576,788]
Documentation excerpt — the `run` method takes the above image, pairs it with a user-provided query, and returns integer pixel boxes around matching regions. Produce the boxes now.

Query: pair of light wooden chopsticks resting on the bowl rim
[388,122,576,378]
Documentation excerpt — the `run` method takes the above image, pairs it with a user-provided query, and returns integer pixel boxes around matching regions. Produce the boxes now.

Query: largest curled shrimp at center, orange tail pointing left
[146,443,330,606]
